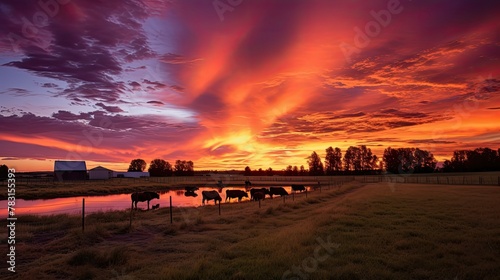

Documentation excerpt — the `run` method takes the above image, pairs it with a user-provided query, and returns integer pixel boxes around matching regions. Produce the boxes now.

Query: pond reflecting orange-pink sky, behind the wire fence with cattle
[0,186,311,218]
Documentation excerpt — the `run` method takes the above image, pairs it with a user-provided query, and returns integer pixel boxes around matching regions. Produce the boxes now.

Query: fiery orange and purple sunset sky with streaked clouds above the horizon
[0,0,500,171]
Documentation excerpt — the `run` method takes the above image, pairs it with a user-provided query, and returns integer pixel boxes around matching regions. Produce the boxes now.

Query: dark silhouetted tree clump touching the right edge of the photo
[442,148,500,172]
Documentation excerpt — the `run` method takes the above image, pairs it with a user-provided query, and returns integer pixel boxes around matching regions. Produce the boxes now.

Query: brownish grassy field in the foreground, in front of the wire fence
[0,182,500,279]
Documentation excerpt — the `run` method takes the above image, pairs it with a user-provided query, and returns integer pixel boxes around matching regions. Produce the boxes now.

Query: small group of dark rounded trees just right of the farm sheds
[128,158,194,177]
